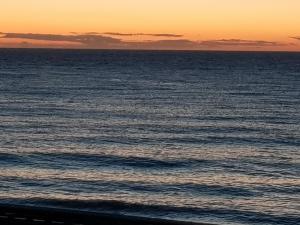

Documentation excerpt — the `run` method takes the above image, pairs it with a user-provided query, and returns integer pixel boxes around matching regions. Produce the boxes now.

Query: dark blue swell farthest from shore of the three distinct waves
[0,151,298,178]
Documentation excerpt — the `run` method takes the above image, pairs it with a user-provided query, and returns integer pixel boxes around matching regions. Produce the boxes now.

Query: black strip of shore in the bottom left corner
[0,204,212,225]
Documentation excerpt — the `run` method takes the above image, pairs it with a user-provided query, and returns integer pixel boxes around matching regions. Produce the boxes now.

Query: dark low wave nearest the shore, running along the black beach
[2,198,300,225]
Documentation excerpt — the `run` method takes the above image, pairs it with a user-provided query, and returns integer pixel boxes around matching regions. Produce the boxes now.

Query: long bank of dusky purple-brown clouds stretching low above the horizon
[0,32,284,50]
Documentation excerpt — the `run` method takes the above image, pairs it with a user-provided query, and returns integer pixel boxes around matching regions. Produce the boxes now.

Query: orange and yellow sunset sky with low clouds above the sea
[0,0,300,51]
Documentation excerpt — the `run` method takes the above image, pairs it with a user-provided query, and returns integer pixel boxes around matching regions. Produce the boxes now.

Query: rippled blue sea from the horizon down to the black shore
[0,49,300,225]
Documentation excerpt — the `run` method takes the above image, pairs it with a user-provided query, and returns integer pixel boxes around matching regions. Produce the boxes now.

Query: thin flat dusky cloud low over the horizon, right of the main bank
[201,39,282,47]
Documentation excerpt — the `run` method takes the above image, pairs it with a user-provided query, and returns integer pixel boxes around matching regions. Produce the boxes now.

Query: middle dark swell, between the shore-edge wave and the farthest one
[0,176,262,198]
